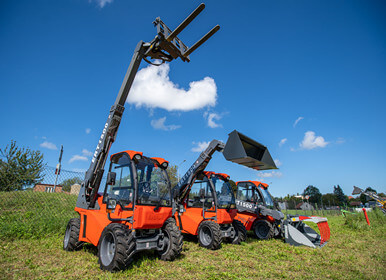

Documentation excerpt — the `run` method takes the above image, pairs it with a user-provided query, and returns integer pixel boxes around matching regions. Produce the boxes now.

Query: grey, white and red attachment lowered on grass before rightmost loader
[283,216,330,248]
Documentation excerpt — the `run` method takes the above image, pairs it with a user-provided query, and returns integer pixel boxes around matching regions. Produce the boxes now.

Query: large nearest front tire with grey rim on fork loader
[98,223,135,272]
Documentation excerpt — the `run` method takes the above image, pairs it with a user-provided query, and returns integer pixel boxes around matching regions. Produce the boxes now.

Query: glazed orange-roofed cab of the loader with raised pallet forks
[103,151,172,210]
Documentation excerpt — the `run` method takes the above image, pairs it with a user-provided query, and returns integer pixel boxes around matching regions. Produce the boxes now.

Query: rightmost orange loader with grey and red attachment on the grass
[236,181,330,248]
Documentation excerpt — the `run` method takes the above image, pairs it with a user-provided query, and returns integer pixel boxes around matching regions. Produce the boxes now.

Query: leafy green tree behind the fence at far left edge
[0,141,45,191]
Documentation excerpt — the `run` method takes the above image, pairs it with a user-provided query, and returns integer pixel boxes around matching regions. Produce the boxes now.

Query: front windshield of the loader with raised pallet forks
[135,157,171,206]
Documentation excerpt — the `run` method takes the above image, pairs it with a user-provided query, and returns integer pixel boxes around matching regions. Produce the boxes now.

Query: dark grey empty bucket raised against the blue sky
[223,130,277,170]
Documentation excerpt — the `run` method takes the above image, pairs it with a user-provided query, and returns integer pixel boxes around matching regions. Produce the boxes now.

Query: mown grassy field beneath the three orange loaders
[0,191,386,279]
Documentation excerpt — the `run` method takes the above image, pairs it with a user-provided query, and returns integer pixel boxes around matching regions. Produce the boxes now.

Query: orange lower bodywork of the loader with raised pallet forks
[75,196,172,246]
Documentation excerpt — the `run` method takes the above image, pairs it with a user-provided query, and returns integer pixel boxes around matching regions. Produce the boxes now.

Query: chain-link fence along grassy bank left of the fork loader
[0,167,100,239]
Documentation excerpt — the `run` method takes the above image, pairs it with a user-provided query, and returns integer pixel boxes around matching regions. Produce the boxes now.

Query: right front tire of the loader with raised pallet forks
[158,218,183,261]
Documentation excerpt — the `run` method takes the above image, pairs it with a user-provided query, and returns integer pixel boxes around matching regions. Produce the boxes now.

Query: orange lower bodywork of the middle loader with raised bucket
[175,205,237,235]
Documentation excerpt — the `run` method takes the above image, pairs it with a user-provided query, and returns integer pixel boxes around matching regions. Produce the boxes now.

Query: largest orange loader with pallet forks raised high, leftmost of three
[63,4,220,271]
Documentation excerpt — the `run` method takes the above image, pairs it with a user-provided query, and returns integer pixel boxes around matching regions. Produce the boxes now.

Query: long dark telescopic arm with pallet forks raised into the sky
[76,4,220,209]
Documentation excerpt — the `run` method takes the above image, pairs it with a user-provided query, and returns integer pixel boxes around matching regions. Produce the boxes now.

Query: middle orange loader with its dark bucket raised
[173,130,274,250]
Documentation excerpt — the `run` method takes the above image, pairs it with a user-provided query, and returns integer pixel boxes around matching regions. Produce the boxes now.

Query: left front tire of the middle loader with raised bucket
[198,221,222,250]
